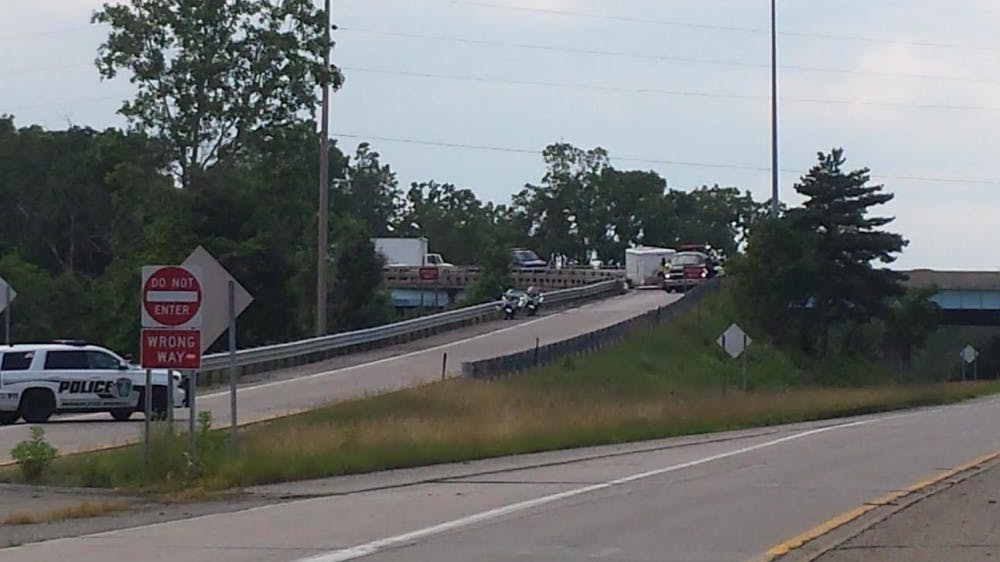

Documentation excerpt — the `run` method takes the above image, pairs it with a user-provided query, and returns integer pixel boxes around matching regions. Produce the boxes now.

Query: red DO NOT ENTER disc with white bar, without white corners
[142,266,201,326]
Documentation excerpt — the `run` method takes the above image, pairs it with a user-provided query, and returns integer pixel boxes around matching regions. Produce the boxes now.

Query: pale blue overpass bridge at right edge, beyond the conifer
[901,269,1000,326]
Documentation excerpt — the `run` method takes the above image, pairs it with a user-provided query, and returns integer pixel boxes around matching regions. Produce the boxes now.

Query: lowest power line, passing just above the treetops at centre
[332,132,1000,185]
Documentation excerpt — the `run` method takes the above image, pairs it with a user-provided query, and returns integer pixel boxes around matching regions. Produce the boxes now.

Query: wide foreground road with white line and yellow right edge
[0,398,1000,562]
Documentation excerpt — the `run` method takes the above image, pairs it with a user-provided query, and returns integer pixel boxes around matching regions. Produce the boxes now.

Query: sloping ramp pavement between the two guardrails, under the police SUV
[0,291,680,463]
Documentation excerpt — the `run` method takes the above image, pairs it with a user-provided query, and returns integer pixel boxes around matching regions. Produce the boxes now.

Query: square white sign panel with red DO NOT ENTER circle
[142,266,202,329]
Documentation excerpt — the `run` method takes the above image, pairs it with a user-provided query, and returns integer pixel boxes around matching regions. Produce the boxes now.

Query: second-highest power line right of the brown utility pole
[340,26,1000,84]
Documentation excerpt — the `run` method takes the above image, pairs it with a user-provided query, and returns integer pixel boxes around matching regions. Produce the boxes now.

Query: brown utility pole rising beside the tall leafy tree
[316,0,331,336]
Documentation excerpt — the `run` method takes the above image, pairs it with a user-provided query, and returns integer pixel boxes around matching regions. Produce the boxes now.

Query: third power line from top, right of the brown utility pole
[341,66,1000,111]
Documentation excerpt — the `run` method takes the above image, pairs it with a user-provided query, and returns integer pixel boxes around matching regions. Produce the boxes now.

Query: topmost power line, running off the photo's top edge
[432,0,1000,51]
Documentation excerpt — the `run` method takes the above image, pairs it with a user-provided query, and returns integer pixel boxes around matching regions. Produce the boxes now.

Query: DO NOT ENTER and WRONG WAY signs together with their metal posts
[140,265,204,456]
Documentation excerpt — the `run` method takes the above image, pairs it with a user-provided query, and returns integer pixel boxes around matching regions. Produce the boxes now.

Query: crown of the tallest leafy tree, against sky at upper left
[92,0,343,187]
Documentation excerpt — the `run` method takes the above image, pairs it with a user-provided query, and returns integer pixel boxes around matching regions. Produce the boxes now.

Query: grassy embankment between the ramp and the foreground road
[6,284,1000,491]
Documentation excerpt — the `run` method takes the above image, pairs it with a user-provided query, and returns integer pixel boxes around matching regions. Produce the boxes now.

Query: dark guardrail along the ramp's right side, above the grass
[462,279,721,379]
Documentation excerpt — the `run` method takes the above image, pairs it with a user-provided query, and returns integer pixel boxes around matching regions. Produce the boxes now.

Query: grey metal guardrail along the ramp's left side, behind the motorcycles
[198,280,625,385]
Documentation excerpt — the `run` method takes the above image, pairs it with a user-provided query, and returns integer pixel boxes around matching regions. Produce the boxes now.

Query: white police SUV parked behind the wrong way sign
[0,341,188,425]
